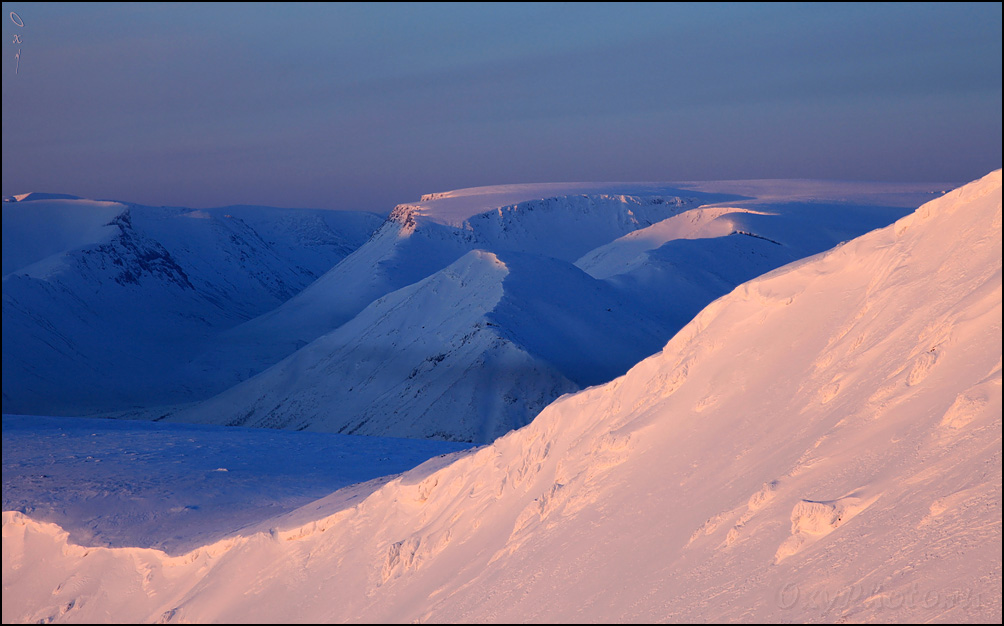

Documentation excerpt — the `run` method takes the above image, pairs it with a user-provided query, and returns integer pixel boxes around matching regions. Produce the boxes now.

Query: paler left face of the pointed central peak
[171,251,575,440]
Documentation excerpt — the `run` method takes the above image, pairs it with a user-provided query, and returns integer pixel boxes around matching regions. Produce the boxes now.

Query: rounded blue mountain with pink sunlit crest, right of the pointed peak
[576,201,916,338]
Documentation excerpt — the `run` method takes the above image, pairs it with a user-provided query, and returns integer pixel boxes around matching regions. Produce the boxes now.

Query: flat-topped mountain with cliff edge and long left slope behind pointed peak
[186,188,733,384]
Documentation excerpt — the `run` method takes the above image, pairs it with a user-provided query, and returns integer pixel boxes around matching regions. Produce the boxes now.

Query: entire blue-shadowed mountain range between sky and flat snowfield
[3,182,937,442]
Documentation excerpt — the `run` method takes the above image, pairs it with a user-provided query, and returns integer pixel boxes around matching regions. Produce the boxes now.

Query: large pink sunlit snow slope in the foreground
[3,171,1001,623]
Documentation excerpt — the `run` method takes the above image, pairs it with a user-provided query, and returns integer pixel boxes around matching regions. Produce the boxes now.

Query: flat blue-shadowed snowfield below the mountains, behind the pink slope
[3,415,467,553]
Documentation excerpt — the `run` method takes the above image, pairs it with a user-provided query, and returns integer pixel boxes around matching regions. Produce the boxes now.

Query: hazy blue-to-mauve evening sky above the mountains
[2,2,1001,213]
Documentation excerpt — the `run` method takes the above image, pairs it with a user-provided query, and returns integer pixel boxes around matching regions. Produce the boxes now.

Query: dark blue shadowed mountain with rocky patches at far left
[3,200,382,415]
